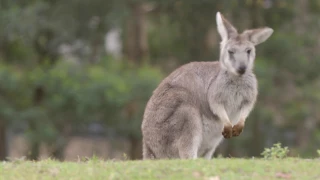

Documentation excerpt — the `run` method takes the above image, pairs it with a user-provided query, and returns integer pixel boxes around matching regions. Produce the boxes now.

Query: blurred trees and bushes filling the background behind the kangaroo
[0,0,320,160]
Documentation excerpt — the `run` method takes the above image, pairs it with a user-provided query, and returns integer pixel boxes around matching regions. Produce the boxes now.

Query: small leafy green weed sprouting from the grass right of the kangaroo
[261,143,289,159]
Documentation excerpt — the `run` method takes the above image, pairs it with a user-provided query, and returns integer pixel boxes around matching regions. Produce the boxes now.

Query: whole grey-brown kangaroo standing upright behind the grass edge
[141,12,273,159]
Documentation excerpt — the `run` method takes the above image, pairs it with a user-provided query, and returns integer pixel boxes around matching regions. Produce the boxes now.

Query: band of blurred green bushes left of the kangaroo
[0,56,162,145]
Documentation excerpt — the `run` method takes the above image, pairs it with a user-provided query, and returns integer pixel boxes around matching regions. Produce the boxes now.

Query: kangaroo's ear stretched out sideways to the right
[243,27,273,45]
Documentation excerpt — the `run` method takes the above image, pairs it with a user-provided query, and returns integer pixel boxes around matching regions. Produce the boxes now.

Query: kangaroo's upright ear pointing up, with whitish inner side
[216,12,238,41]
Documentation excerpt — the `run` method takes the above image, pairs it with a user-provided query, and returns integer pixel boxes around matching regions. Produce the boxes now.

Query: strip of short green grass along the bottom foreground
[0,158,320,180]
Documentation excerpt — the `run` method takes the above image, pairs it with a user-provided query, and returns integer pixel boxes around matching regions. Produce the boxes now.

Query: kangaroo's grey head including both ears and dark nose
[216,12,273,76]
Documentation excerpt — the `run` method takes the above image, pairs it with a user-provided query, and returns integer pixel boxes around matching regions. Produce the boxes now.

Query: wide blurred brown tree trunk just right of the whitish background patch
[125,2,148,64]
